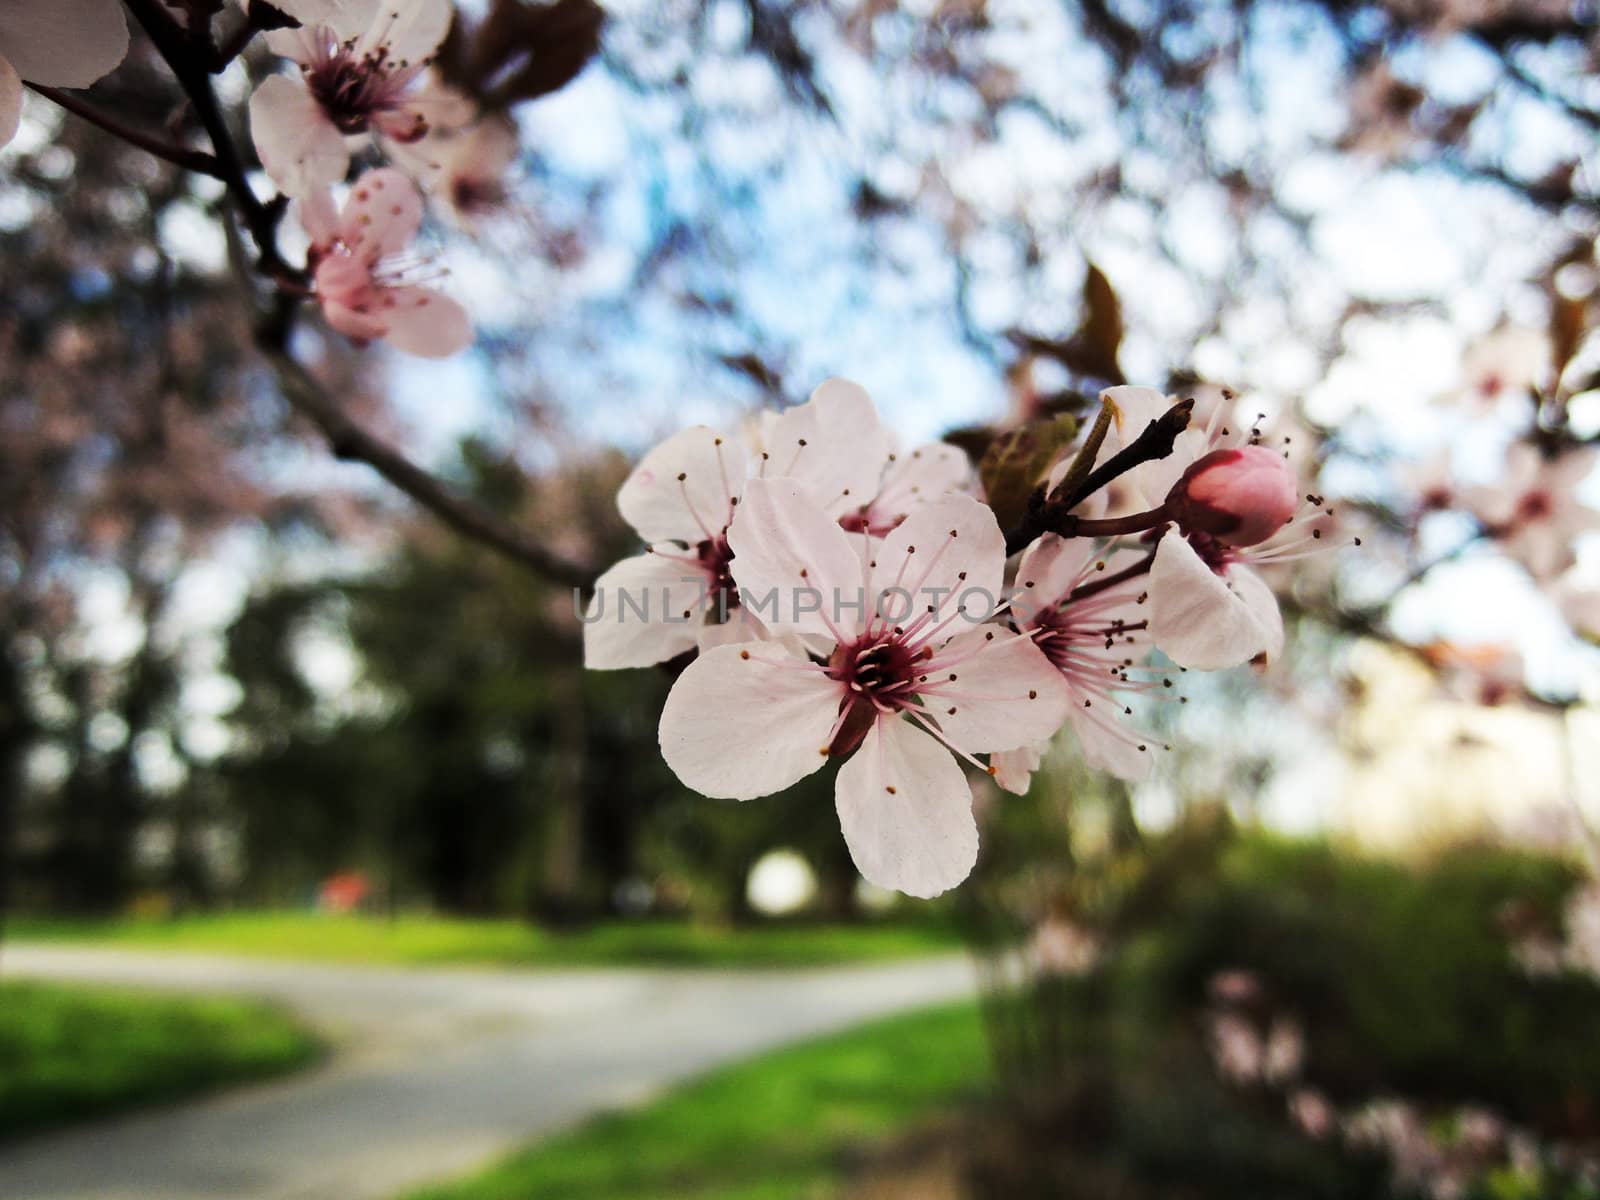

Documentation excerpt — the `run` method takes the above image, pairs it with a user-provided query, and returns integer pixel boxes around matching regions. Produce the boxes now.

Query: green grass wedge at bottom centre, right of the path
[414,1005,987,1200]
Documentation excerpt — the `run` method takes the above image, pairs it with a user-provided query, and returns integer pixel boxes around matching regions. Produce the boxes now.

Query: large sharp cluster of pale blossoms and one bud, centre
[584,379,1326,896]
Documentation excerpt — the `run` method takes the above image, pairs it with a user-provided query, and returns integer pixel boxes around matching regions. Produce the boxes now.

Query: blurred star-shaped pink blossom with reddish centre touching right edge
[1464,442,1600,579]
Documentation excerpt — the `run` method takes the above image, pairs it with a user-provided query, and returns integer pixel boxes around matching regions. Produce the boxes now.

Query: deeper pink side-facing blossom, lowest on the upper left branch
[301,166,472,358]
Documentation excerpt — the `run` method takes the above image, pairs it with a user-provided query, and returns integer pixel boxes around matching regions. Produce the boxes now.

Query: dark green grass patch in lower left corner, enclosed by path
[0,982,322,1138]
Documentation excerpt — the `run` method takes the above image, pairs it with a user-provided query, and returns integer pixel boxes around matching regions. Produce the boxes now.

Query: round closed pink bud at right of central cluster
[1166,446,1299,546]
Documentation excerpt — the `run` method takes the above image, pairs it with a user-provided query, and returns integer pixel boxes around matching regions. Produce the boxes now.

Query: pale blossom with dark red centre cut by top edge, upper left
[250,0,470,197]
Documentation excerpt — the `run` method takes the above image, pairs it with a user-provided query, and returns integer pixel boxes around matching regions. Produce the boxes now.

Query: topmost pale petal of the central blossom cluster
[763,379,890,518]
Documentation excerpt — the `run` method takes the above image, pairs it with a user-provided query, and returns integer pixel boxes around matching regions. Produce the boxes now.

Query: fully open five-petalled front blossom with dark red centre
[661,478,1070,896]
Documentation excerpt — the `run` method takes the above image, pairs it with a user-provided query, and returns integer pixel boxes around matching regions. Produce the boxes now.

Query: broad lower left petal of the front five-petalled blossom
[661,645,842,800]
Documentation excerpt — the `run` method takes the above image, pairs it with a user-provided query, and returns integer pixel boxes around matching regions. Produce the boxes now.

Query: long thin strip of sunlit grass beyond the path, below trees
[8,912,960,966]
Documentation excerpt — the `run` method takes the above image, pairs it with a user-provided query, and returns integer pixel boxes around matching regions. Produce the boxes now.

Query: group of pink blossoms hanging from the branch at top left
[250,0,517,357]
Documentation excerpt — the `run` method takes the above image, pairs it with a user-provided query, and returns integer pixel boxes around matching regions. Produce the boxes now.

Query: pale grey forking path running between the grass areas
[0,944,973,1200]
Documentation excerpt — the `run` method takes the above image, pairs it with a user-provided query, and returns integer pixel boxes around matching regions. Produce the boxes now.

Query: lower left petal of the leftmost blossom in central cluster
[584,554,706,670]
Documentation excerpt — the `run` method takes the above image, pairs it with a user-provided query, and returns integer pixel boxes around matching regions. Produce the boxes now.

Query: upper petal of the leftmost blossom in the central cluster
[616,426,744,547]
